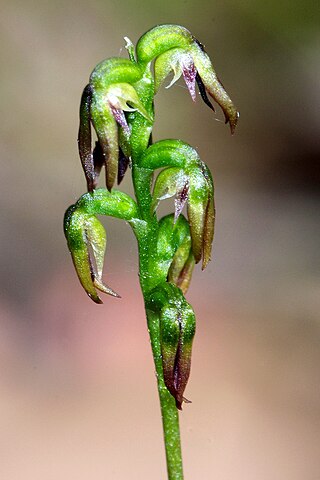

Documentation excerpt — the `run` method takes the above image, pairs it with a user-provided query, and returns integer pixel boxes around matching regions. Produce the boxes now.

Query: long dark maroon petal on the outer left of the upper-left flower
[78,84,95,191]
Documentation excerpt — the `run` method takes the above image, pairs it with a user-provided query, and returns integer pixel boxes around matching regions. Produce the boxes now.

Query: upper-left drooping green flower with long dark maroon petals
[78,58,152,191]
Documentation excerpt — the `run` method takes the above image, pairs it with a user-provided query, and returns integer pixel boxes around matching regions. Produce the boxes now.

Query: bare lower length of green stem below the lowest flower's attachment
[146,310,183,480]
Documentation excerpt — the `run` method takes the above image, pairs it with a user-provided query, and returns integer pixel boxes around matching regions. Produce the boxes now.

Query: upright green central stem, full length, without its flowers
[130,68,183,480]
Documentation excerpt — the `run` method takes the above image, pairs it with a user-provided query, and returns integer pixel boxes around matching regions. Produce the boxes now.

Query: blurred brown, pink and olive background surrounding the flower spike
[0,0,320,480]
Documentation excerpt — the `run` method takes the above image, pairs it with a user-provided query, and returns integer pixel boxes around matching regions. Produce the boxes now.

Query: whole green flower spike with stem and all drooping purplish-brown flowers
[64,25,238,480]
